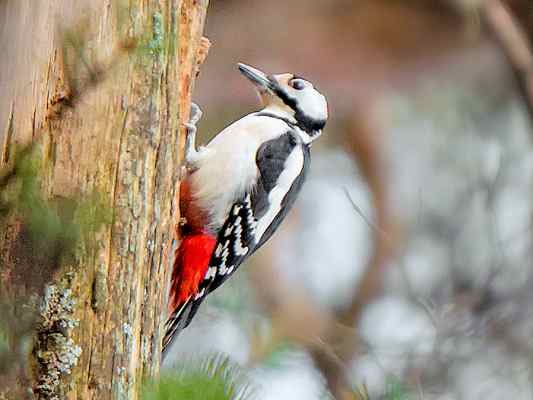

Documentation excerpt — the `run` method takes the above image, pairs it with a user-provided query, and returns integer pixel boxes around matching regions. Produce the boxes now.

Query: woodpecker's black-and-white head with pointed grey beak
[239,64,328,139]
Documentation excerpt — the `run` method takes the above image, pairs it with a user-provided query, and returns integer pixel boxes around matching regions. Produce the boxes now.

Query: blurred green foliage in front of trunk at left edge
[0,146,111,268]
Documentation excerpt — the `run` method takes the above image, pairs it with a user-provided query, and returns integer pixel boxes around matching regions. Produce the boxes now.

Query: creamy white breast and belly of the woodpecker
[186,114,288,230]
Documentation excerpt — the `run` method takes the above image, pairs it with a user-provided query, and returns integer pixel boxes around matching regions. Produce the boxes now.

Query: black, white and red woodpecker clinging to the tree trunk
[163,64,328,352]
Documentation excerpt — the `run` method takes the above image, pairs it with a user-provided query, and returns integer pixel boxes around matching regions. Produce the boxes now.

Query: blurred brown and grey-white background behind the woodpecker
[162,0,533,400]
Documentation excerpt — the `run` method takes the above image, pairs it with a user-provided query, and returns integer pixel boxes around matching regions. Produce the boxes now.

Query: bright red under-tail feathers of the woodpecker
[168,233,217,315]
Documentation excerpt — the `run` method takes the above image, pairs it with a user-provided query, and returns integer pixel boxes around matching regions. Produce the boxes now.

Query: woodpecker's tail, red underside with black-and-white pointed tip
[163,233,216,355]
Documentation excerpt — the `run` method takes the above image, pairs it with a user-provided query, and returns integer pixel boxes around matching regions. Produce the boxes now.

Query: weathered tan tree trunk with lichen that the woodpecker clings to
[0,0,207,400]
